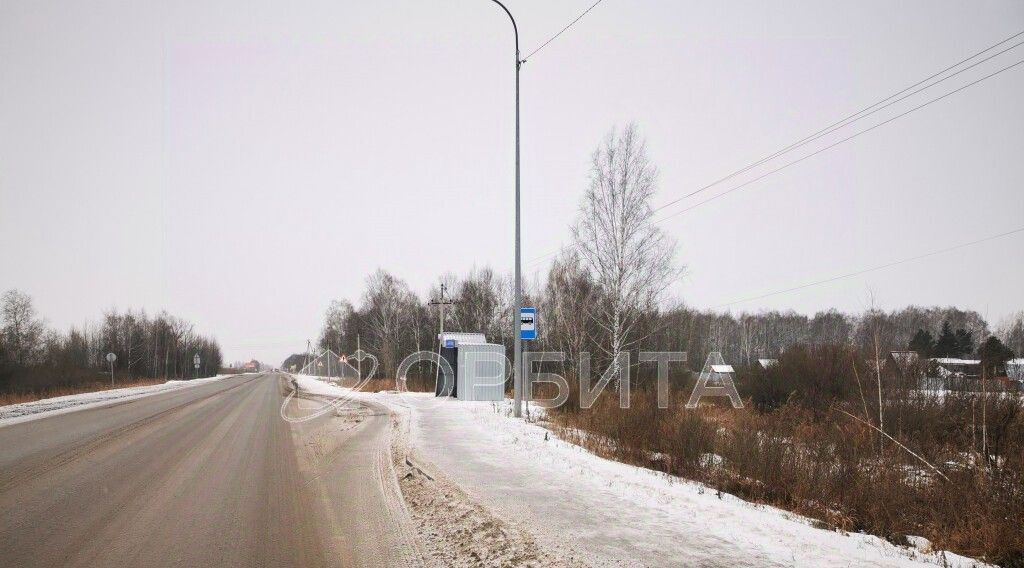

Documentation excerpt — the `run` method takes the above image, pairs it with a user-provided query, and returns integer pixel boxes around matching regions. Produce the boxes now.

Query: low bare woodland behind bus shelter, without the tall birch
[318,264,1024,377]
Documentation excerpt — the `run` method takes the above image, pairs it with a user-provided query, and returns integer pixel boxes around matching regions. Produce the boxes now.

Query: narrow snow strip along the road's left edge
[0,375,236,426]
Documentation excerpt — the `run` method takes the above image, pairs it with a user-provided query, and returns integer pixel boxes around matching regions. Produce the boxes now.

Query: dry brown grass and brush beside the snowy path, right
[553,347,1024,566]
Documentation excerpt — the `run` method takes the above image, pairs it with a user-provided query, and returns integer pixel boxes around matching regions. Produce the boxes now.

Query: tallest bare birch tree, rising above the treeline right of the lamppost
[572,125,681,378]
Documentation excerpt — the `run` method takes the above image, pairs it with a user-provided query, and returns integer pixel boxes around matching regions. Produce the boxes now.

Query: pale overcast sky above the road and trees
[0,0,1024,363]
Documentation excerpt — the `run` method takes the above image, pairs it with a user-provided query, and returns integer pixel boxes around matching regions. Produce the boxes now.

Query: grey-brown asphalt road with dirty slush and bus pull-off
[0,374,420,567]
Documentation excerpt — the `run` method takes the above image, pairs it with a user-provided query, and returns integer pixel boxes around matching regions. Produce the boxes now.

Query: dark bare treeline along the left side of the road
[0,290,222,392]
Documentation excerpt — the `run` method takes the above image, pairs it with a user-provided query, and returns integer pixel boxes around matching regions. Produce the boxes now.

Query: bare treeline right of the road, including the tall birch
[319,125,1024,377]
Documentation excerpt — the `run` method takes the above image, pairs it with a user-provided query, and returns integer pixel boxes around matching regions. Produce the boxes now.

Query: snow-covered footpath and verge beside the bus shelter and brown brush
[297,377,979,566]
